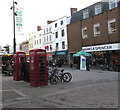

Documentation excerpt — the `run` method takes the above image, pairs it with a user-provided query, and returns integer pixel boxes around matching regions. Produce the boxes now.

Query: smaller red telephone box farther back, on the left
[13,52,26,81]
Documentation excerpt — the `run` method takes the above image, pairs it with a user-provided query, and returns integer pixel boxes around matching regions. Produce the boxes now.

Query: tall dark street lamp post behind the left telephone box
[10,0,17,53]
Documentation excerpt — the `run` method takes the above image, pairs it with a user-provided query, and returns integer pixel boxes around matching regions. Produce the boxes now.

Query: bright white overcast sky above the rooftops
[0,0,100,46]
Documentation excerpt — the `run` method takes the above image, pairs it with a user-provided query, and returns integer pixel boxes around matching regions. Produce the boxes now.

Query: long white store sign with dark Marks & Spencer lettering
[82,43,120,52]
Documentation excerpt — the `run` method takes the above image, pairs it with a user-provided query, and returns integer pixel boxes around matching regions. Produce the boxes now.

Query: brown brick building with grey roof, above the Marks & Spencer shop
[67,0,120,64]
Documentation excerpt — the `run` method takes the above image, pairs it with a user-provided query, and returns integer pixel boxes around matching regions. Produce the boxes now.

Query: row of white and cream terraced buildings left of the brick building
[28,16,71,63]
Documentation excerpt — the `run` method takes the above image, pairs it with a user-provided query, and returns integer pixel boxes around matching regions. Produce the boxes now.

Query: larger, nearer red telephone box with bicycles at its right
[29,49,48,86]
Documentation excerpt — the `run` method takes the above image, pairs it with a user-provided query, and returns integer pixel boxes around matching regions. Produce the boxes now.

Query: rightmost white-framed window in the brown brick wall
[108,19,116,34]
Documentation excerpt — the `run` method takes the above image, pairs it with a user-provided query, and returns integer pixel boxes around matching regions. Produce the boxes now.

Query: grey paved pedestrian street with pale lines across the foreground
[2,67,118,108]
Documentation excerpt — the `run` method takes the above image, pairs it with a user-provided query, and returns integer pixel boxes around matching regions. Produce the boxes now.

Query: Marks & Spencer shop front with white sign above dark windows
[82,43,120,69]
